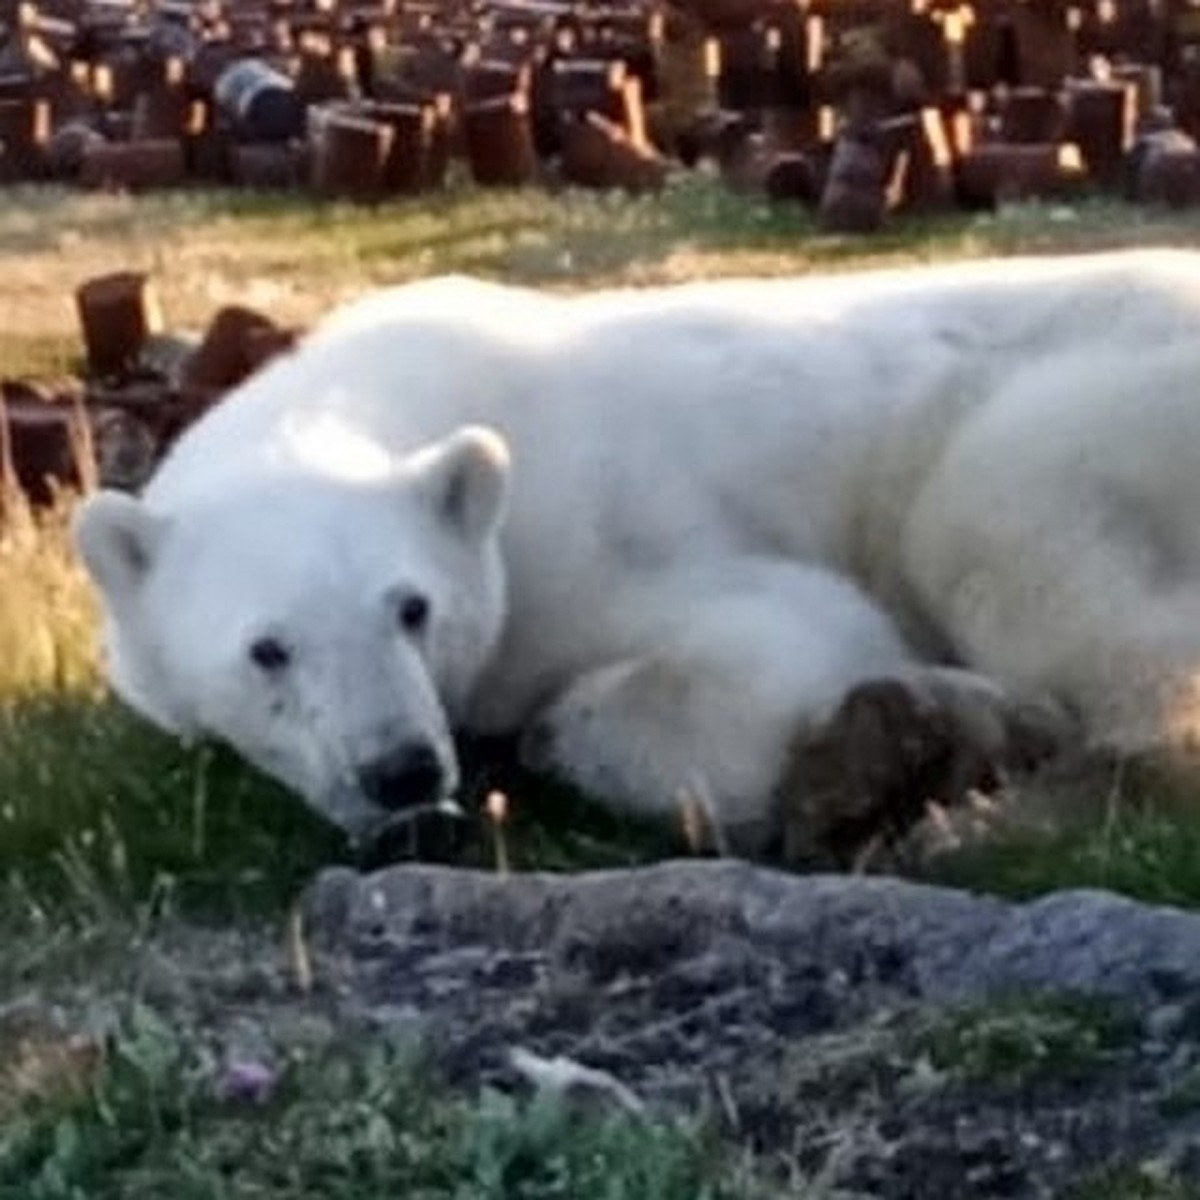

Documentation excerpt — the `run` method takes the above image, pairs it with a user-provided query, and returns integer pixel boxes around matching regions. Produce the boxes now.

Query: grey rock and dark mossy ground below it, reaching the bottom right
[288,860,1200,1200]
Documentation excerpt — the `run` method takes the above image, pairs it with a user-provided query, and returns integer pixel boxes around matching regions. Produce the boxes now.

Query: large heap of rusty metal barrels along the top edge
[0,0,1200,223]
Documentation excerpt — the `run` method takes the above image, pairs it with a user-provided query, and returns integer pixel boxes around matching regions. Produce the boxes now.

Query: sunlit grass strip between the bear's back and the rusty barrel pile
[7,178,1200,345]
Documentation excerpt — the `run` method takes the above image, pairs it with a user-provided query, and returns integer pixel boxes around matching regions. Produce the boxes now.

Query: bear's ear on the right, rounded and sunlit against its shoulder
[419,425,511,541]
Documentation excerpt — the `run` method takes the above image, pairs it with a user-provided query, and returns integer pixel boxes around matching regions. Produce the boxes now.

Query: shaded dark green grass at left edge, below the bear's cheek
[0,696,344,911]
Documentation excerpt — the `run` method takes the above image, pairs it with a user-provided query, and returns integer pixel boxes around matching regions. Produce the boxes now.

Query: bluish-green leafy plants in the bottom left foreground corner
[0,1010,799,1200]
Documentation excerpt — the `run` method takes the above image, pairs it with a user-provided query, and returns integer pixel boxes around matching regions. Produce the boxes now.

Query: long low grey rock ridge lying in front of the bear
[306,860,1200,1003]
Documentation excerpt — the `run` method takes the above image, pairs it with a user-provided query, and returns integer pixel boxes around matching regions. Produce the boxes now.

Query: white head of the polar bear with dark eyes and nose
[74,427,509,839]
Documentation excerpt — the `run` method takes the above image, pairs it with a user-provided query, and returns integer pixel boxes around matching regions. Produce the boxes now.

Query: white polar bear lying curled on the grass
[76,251,1200,854]
